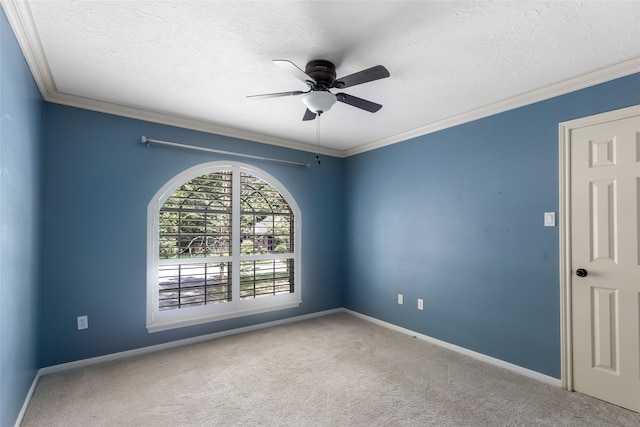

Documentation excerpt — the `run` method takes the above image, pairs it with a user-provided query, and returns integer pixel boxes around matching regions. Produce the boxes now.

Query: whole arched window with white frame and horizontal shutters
[147,162,301,332]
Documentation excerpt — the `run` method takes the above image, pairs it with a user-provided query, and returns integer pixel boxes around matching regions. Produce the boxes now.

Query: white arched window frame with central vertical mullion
[147,161,302,332]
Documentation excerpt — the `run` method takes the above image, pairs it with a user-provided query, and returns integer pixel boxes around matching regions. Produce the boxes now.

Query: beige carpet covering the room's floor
[22,313,640,427]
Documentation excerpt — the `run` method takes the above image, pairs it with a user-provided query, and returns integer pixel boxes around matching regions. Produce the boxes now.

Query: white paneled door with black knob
[570,116,640,412]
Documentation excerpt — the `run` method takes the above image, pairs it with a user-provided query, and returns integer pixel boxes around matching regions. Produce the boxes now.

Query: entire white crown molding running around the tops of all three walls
[0,0,640,157]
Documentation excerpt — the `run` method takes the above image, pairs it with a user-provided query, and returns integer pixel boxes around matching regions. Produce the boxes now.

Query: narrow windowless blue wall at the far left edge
[0,9,42,426]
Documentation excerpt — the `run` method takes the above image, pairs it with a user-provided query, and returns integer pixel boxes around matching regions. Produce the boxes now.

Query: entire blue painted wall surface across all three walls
[0,5,640,425]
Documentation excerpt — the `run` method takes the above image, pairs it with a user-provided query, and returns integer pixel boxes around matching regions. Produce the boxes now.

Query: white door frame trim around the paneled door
[558,105,640,391]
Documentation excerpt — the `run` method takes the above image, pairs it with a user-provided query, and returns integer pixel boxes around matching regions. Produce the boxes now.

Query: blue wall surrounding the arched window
[40,103,345,366]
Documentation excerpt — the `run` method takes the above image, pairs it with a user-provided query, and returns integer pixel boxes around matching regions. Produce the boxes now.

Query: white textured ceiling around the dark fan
[2,0,640,155]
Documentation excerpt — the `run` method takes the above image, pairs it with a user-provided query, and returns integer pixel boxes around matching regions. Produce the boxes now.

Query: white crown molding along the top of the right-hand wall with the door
[342,56,640,157]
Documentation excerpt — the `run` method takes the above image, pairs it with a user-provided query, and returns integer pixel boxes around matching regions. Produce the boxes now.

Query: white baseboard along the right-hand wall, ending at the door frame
[342,308,562,387]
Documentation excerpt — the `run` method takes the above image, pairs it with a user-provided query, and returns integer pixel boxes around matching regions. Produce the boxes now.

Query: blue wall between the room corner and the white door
[345,74,640,378]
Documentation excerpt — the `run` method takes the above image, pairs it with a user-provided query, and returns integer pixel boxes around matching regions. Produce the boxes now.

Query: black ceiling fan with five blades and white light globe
[247,59,390,120]
